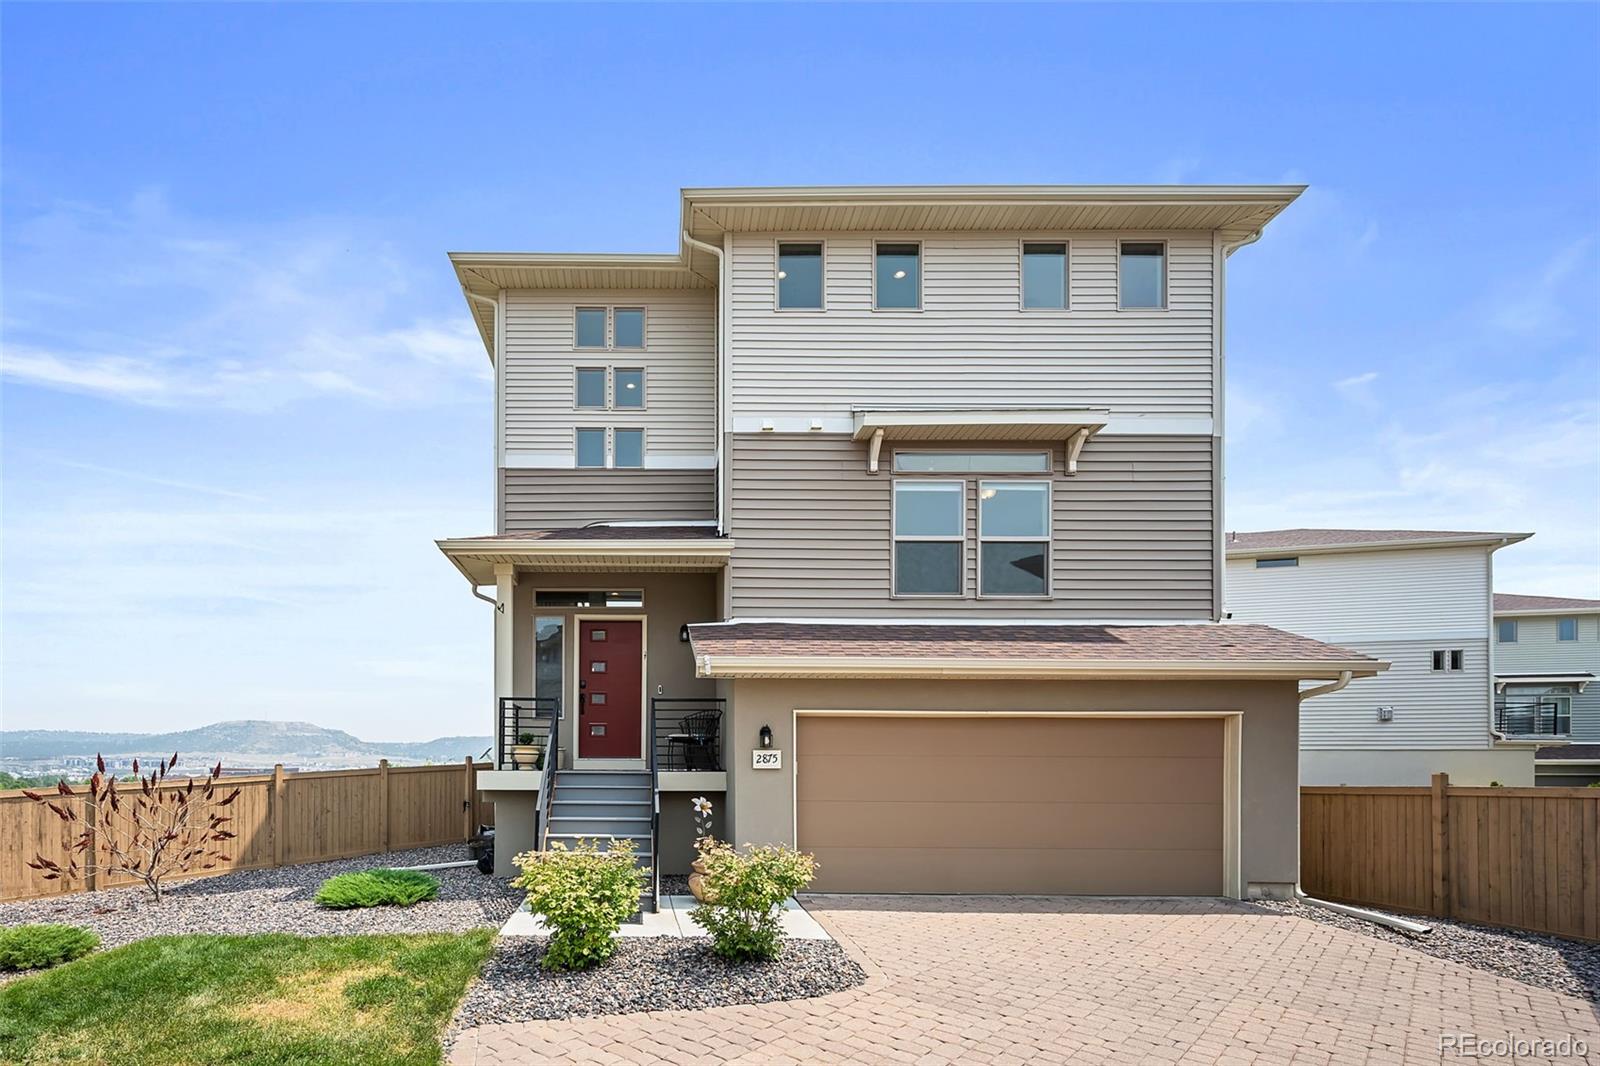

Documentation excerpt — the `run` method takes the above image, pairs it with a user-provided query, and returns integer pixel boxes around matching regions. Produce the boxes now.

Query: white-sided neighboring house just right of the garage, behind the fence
[1227,530,1534,786]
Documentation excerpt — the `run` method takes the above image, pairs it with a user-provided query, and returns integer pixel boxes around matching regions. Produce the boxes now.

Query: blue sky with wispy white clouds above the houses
[0,5,1600,738]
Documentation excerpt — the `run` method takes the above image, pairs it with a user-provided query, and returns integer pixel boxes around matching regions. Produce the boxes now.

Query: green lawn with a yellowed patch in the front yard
[0,930,494,1066]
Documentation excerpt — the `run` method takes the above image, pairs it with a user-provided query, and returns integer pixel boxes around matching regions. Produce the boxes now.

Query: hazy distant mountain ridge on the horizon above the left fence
[0,720,491,765]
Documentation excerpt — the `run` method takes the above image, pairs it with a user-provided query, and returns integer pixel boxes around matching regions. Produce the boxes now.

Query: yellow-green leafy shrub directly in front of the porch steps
[512,840,645,970]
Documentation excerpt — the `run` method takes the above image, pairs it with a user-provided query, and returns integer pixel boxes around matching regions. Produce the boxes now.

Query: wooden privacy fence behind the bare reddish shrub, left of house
[0,759,488,900]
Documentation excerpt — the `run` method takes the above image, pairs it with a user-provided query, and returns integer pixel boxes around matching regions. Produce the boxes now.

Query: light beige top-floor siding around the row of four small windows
[730,232,1213,418]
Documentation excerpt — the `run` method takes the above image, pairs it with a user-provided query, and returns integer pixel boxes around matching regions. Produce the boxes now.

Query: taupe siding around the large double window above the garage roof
[731,435,1214,619]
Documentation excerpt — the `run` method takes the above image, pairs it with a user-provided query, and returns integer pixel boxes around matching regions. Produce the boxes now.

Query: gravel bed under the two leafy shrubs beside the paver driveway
[453,936,867,1032]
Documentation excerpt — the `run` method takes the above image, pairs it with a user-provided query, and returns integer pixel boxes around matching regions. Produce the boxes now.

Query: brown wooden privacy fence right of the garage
[1301,773,1600,940]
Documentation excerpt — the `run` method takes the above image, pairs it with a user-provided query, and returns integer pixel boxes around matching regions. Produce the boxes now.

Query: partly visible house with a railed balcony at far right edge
[1494,592,1600,786]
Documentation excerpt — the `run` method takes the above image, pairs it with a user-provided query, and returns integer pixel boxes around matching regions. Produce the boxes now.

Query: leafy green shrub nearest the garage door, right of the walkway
[693,840,816,959]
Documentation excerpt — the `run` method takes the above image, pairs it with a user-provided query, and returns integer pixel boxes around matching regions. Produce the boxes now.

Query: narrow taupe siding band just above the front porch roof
[501,471,717,533]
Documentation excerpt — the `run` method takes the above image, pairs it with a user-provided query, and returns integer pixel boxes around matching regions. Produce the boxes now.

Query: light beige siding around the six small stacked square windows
[504,290,715,463]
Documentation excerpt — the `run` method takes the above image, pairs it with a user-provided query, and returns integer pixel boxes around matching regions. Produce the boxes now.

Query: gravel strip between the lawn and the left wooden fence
[0,844,523,948]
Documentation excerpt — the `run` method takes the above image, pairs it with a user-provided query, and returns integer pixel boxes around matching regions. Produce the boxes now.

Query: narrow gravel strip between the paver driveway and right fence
[1250,900,1600,1002]
